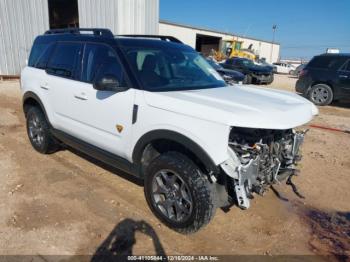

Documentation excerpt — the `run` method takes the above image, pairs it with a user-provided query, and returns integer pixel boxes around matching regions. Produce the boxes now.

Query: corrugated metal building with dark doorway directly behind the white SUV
[0,0,159,76]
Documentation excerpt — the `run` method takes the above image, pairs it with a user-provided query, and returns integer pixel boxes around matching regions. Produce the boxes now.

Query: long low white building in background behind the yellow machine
[159,20,280,63]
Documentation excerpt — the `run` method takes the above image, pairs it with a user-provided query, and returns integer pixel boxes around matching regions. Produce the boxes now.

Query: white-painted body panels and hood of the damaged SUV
[21,64,318,165]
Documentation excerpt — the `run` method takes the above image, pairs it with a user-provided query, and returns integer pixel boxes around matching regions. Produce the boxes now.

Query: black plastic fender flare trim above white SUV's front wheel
[132,129,220,174]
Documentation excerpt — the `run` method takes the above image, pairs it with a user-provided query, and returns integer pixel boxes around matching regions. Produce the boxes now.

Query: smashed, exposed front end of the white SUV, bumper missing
[221,127,307,209]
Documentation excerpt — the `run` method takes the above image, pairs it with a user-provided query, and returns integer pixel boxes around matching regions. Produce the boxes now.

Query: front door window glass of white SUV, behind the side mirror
[81,44,125,85]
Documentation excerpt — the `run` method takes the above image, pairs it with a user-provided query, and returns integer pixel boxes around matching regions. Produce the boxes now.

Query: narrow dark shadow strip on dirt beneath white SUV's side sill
[63,146,143,187]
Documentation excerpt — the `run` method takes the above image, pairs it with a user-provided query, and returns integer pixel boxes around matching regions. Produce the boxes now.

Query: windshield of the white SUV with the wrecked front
[126,45,226,91]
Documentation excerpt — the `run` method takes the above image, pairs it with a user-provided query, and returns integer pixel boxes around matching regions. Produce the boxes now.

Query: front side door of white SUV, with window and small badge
[62,43,135,158]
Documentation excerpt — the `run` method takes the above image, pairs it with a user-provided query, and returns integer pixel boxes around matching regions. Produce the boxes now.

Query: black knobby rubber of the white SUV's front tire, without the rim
[144,152,216,234]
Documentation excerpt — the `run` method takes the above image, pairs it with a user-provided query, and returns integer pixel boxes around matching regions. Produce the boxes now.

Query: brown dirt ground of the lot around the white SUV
[0,75,350,261]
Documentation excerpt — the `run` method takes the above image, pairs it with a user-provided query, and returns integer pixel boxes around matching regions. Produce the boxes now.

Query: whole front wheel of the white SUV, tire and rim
[145,152,215,234]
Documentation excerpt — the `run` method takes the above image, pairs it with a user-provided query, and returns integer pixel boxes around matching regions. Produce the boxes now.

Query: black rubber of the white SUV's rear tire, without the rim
[26,106,60,154]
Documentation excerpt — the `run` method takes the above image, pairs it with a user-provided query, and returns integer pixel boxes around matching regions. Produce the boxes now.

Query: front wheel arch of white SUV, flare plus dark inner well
[132,130,220,176]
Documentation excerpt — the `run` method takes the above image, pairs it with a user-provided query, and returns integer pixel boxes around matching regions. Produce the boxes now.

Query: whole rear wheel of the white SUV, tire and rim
[26,107,59,154]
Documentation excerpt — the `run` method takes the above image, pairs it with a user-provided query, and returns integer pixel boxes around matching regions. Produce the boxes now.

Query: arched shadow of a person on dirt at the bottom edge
[91,218,166,262]
